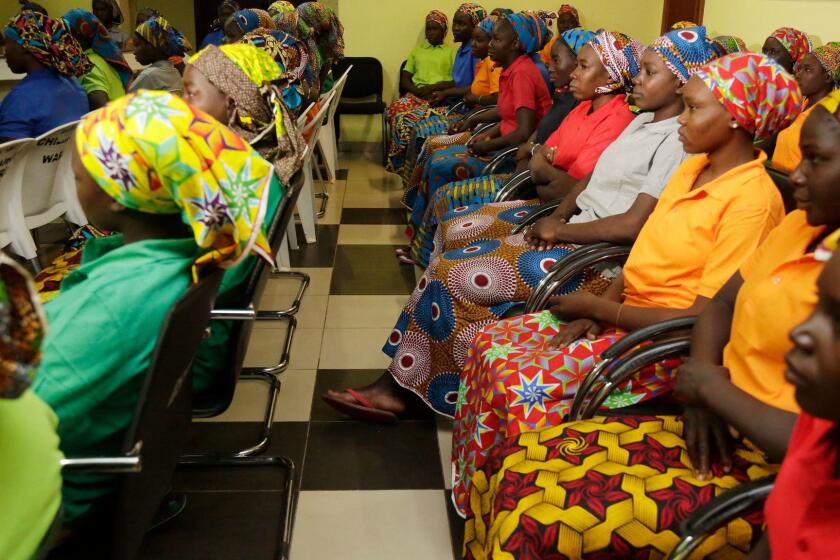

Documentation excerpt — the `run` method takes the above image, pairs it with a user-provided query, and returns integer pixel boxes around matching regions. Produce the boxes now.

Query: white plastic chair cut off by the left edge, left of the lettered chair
[0,138,35,255]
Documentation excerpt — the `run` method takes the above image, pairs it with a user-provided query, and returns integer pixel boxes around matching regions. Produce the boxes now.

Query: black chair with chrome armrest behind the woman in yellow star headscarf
[61,270,223,560]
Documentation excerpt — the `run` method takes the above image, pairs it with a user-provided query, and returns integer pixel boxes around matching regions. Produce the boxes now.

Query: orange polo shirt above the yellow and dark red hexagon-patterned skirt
[723,210,825,412]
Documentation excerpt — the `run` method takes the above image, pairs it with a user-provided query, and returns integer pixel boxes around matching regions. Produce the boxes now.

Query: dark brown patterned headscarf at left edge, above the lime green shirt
[0,253,46,399]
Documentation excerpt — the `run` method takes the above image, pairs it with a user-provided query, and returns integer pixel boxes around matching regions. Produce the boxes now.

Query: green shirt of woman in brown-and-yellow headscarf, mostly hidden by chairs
[192,175,285,391]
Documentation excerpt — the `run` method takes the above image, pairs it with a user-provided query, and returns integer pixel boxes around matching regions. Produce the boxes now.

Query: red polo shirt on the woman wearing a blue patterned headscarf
[499,55,551,136]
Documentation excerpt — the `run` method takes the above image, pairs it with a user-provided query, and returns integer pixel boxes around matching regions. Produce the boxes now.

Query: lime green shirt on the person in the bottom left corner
[0,391,61,560]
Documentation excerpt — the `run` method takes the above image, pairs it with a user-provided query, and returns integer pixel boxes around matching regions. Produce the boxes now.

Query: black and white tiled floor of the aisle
[143,151,463,560]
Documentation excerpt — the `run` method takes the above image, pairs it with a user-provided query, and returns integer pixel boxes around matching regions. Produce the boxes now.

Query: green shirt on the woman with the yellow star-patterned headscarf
[33,235,198,524]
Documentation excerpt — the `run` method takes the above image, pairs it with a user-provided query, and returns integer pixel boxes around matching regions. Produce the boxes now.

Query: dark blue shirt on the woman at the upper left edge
[0,69,90,140]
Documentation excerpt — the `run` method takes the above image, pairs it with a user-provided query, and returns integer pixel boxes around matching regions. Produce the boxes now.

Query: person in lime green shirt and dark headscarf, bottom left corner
[0,253,62,560]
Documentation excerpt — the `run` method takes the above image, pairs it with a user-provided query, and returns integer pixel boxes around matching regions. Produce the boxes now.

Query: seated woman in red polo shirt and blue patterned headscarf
[411,12,552,256]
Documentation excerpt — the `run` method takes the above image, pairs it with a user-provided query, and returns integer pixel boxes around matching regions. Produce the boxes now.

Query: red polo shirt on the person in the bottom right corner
[764,413,840,560]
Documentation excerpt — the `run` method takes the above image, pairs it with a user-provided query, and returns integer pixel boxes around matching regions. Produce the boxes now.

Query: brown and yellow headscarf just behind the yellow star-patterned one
[189,44,304,184]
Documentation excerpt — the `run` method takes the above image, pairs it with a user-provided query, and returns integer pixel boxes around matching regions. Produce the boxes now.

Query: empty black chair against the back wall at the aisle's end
[333,56,388,162]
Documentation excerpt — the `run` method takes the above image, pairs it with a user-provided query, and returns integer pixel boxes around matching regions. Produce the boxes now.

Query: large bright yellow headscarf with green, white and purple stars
[76,90,273,272]
